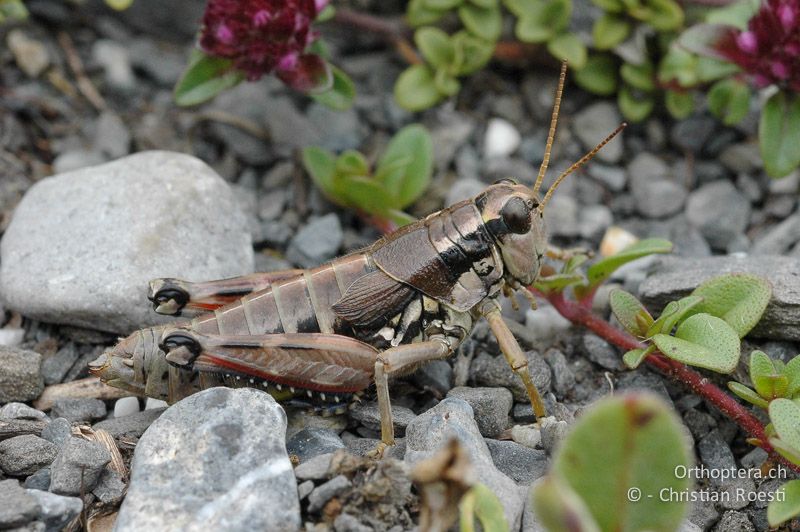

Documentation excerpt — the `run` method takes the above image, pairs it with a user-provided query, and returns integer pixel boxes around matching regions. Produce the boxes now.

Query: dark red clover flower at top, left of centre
[200,0,329,91]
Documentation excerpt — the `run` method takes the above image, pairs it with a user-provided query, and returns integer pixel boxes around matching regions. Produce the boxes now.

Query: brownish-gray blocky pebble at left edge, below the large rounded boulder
[0,348,44,403]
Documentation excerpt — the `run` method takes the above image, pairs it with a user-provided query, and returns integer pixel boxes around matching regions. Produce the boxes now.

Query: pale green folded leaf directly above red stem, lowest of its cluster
[653,314,740,373]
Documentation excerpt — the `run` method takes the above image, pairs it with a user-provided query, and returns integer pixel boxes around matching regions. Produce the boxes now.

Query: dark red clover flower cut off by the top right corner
[715,0,800,91]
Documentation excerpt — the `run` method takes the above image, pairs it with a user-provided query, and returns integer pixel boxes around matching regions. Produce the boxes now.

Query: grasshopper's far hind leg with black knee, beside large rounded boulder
[147,270,303,316]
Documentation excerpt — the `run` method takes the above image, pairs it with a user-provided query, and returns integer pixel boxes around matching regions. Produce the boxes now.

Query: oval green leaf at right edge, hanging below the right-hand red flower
[758,91,800,177]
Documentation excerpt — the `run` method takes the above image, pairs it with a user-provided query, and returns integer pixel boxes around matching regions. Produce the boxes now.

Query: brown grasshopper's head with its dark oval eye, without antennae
[475,179,547,285]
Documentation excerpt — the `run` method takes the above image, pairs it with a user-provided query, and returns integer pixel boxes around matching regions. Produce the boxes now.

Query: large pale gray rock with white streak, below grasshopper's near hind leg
[115,388,300,532]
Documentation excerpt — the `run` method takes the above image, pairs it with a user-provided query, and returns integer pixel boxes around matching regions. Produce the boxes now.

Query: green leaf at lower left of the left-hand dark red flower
[174,50,244,106]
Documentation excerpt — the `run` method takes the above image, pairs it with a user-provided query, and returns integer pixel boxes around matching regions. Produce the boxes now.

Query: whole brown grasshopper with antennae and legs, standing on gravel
[90,63,624,453]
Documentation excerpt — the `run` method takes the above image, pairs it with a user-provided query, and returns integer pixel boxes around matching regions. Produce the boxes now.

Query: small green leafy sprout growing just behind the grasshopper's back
[302,124,433,225]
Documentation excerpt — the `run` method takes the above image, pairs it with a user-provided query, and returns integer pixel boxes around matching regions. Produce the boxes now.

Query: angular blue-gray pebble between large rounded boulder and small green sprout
[286,213,344,268]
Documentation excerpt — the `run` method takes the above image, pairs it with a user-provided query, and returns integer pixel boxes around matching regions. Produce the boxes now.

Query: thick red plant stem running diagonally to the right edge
[545,293,800,472]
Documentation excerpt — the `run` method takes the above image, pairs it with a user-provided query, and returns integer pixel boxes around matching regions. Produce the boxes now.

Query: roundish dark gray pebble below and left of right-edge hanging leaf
[686,180,750,250]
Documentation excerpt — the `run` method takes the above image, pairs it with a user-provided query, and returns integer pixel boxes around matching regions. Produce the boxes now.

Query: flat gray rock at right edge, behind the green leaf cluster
[639,255,800,341]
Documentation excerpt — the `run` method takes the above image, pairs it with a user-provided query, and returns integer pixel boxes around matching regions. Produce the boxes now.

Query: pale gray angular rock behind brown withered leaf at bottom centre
[405,397,525,530]
